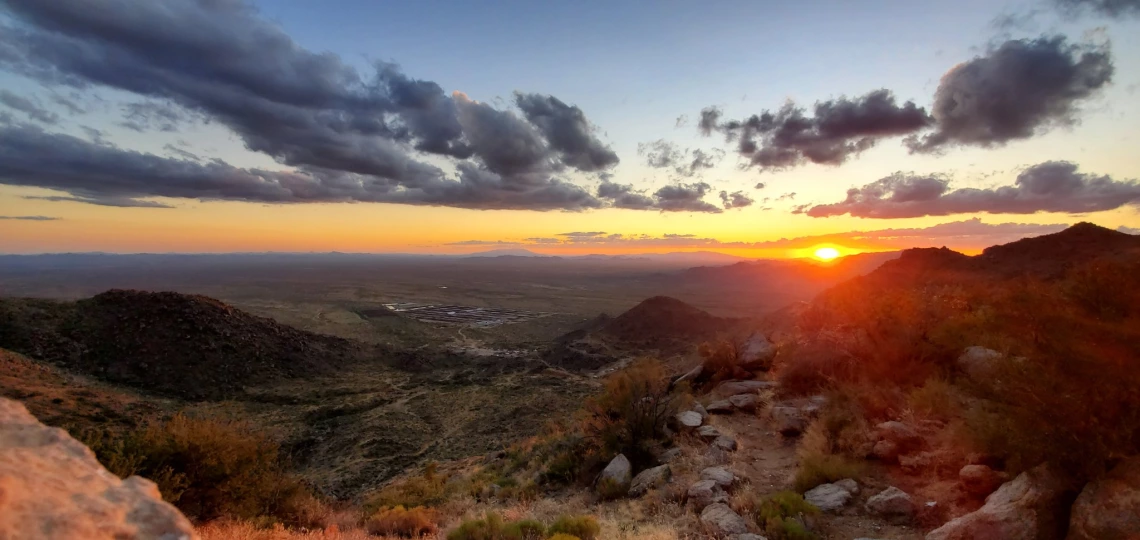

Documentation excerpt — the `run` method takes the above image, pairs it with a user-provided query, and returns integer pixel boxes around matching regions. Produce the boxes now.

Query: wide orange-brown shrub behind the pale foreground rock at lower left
[78,415,314,525]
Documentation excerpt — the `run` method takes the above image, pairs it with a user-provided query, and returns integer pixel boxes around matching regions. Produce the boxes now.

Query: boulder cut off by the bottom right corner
[1068,457,1140,540]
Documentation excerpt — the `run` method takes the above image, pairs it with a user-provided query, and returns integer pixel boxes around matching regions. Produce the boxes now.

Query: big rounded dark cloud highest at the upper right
[907,36,1113,152]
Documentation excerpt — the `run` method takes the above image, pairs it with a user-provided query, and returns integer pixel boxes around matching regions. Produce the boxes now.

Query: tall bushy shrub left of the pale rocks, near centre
[581,359,677,467]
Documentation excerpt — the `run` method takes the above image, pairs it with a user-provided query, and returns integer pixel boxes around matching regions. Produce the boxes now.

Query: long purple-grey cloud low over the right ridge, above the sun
[804,162,1140,219]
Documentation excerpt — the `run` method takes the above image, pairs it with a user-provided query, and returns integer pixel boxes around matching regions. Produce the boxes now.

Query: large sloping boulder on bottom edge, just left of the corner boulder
[926,465,1070,540]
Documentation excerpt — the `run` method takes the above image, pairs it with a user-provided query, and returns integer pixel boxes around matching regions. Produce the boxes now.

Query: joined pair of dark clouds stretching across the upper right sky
[698,35,1117,172]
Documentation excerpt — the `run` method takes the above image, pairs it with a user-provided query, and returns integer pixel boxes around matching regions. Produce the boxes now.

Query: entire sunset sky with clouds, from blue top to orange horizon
[0,0,1140,256]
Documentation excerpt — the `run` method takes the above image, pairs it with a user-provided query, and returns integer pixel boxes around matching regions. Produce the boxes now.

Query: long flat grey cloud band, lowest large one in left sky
[0,125,601,210]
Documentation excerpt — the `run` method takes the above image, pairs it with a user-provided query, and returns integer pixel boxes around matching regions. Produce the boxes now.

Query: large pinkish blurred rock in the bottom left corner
[0,398,197,540]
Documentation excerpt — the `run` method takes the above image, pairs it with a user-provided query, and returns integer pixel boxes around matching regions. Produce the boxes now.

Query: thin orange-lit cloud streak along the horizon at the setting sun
[448,218,1067,251]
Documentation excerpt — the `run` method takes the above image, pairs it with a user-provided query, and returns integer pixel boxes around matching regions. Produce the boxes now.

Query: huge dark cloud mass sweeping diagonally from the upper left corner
[0,0,618,211]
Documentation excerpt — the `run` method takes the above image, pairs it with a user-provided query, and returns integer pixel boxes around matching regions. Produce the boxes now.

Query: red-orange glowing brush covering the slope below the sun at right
[776,250,1140,477]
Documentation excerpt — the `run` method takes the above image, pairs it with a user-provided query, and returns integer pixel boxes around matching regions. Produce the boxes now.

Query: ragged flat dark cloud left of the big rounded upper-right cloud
[700,89,933,171]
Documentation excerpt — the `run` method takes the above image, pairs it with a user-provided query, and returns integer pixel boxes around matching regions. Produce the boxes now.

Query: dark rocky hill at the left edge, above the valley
[0,291,359,400]
